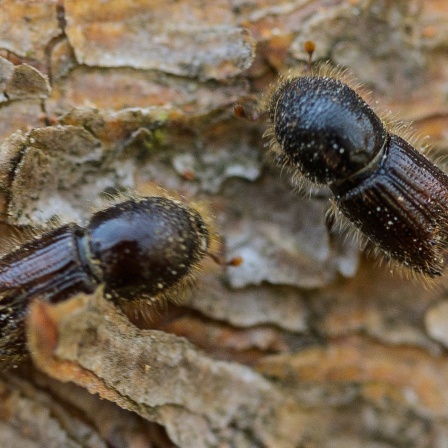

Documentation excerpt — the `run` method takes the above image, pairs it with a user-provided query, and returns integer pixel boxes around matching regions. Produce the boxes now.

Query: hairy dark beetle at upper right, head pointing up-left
[264,43,448,278]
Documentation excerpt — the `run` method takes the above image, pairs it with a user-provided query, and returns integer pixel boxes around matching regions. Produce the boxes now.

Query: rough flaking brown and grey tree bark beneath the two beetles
[0,0,448,448]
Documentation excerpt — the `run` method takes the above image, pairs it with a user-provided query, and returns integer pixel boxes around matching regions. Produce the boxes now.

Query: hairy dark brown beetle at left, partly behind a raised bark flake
[0,196,226,368]
